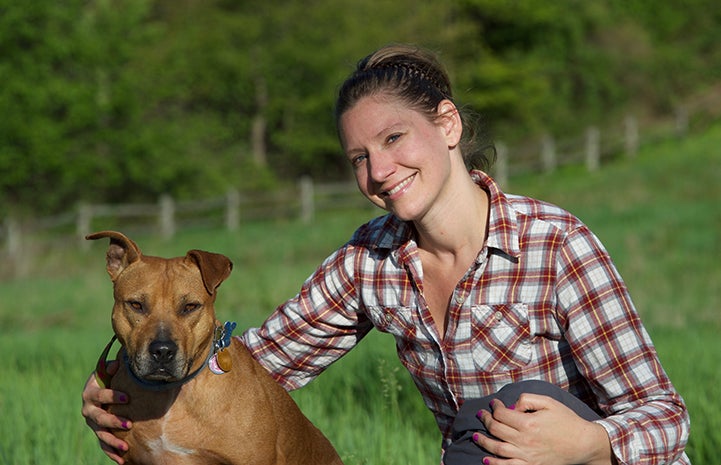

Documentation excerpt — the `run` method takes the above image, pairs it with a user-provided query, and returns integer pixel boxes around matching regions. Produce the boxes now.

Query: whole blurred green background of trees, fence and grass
[0,0,721,465]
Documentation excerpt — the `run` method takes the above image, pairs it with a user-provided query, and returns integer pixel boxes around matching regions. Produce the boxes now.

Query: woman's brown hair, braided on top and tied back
[335,44,495,170]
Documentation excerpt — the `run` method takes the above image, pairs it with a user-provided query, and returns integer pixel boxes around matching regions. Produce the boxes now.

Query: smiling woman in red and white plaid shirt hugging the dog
[83,46,689,465]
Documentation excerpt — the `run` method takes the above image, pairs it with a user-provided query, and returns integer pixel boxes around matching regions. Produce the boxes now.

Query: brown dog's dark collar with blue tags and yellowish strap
[95,321,236,391]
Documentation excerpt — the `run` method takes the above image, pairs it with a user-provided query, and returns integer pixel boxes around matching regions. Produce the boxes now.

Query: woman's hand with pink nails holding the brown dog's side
[82,361,132,465]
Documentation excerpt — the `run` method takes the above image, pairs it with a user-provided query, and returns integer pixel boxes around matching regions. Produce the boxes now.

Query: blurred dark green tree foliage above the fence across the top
[0,0,721,213]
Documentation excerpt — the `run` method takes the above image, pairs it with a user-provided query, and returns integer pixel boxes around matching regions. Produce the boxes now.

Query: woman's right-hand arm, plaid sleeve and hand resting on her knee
[466,226,689,465]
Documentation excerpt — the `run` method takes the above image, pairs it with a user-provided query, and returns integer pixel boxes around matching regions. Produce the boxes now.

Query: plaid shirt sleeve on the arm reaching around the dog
[241,245,372,390]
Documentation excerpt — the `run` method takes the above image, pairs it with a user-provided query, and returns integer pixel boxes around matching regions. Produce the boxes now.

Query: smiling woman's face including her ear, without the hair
[339,95,460,221]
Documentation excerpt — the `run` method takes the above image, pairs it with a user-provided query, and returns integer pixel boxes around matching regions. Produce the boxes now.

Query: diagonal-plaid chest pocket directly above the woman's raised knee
[471,303,533,373]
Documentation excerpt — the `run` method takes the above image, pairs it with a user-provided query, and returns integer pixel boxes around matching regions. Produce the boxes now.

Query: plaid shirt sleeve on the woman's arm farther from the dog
[557,226,689,464]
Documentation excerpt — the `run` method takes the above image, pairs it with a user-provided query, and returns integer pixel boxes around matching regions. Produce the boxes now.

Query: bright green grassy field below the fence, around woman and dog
[0,126,721,465]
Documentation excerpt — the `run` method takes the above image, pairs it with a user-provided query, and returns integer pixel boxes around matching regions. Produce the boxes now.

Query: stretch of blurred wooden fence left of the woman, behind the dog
[0,178,376,279]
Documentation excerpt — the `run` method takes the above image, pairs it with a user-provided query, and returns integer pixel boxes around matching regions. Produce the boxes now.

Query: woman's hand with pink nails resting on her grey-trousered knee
[473,393,614,465]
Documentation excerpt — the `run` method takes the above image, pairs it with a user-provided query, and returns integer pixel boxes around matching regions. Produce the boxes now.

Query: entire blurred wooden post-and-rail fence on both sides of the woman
[0,102,721,279]
